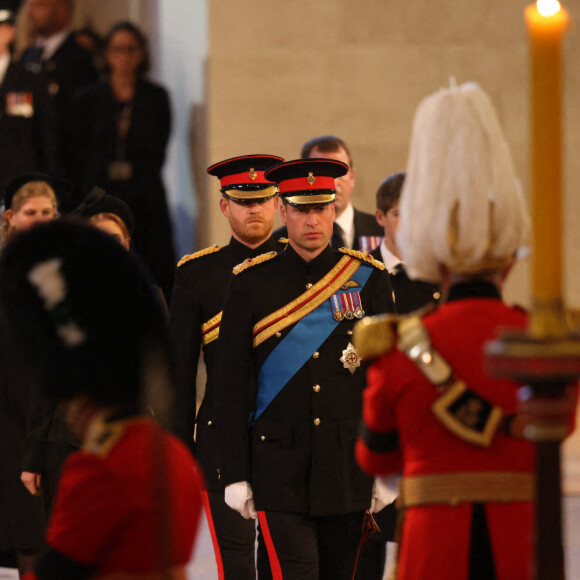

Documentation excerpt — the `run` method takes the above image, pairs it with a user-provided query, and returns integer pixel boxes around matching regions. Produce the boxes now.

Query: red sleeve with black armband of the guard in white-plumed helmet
[356,354,402,475]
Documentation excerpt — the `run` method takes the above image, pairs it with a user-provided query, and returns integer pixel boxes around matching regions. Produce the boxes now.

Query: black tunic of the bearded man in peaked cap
[170,238,280,491]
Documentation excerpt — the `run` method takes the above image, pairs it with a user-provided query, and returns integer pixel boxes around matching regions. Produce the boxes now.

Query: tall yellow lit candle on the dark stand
[525,0,569,336]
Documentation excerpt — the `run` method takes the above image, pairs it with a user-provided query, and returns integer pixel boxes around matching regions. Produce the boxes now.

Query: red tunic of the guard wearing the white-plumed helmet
[356,292,534,580]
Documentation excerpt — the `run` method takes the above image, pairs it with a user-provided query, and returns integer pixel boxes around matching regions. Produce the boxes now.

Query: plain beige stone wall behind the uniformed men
[205,0,580,305]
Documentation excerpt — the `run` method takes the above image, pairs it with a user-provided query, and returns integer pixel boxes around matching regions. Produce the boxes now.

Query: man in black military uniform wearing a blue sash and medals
[216,159,392,580]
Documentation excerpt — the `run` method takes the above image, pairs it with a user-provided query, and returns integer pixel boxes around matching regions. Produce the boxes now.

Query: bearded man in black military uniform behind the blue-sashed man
[171,155,283,580]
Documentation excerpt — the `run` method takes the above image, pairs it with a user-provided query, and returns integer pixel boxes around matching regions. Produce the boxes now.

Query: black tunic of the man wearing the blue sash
[216,246,392,516]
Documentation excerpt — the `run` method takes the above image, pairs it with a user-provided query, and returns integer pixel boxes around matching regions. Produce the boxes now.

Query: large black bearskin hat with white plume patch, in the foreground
[0,222,169,412]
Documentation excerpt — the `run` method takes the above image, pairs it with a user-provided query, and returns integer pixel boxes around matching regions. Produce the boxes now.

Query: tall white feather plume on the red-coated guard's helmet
[397,83,529,282]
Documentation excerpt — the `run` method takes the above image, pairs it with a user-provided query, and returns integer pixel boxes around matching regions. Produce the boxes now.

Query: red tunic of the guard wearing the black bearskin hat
[26,418,202,580]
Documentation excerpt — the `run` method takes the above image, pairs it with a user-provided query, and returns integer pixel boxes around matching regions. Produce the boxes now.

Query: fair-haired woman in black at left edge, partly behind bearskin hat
[0,171,57,575]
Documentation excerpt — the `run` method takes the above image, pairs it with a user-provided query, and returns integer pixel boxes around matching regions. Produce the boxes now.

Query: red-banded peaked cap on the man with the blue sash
[265,158,349,205]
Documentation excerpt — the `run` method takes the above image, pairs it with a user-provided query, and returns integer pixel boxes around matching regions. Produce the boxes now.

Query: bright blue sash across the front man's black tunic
[250,264,373,425]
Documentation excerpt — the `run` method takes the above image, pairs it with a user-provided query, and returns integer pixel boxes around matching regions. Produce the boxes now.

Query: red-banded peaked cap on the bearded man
[207,155,284,203]
